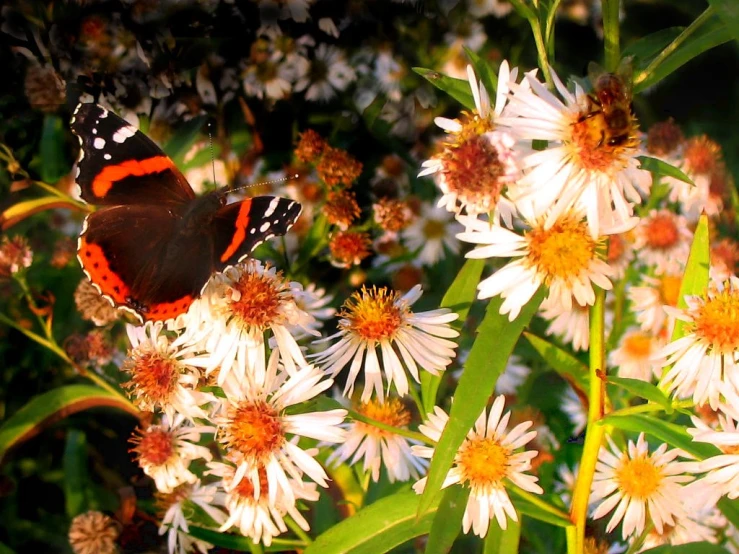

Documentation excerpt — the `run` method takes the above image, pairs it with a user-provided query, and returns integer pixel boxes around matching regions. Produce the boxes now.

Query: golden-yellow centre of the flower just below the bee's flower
[526,217,600,285]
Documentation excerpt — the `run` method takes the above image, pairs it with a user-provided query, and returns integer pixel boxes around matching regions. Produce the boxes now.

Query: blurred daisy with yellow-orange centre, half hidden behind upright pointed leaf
[626,272,683,336]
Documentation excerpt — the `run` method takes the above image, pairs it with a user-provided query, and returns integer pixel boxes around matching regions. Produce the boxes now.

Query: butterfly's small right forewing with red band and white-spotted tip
[213,196,302,270]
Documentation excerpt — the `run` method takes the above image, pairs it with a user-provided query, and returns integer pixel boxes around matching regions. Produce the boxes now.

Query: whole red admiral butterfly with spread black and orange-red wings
[71,104,301,320]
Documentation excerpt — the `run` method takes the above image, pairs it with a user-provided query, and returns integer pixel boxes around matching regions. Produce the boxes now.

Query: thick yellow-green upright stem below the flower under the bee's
[570,289,606,554]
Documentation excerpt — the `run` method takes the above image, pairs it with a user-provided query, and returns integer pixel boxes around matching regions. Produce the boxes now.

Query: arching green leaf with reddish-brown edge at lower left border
[0,385,140,456]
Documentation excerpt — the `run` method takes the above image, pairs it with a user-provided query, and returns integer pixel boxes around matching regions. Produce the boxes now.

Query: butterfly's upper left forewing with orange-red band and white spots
[71,104,195,206]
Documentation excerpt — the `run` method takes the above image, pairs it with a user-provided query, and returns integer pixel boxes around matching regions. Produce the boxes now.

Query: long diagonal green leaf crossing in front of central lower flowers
[418,287,546,515]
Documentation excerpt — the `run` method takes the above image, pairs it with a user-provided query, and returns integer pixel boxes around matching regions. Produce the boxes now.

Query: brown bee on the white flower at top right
[580,58,636,146]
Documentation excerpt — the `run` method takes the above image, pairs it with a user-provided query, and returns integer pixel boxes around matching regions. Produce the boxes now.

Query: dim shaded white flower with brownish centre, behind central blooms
[401,202,462,266]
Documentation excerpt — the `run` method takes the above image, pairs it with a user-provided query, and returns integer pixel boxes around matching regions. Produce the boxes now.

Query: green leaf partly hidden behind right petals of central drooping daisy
[421,259,485,413]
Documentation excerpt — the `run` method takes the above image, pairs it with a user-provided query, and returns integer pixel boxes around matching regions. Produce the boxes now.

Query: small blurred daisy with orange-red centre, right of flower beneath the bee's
[634,210,693,275]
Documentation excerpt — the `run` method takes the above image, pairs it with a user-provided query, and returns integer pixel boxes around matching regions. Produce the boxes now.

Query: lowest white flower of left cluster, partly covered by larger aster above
[206,462,320,547]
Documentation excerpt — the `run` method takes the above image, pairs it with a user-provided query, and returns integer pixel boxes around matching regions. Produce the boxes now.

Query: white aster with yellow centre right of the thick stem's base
[591,433,693,540]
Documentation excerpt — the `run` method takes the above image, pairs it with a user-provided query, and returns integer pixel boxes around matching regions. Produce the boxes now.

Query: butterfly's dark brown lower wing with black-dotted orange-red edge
[77,205,213,320]
